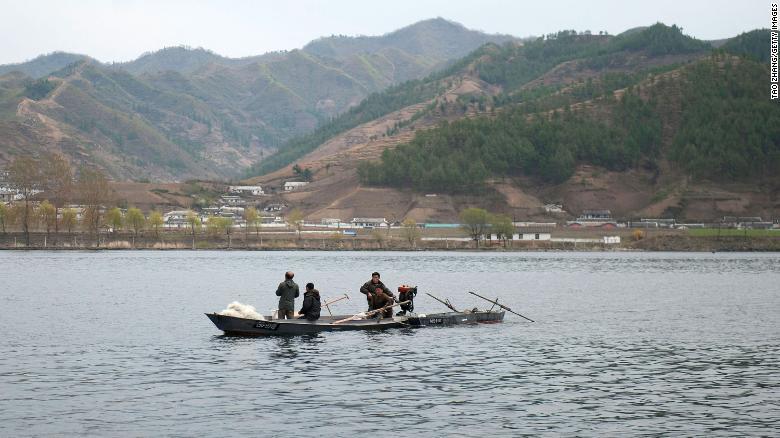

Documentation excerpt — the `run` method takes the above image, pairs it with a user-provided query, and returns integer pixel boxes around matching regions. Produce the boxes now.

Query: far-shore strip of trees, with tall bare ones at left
[0,153,780,251]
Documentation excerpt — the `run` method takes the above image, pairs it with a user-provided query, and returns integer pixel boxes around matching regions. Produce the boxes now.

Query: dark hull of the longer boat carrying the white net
[206,313,409,336]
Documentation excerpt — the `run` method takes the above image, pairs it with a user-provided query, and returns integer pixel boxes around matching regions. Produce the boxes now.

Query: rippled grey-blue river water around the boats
[0,251,780,436]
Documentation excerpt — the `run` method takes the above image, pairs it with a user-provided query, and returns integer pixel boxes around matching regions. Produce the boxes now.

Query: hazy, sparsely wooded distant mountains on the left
[0,19,511,180]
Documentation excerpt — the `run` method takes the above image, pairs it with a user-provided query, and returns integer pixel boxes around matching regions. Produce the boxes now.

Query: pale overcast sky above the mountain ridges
[0,0,771,64]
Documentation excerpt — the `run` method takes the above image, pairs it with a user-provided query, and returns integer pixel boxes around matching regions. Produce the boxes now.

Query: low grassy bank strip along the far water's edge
[0,230,780,252]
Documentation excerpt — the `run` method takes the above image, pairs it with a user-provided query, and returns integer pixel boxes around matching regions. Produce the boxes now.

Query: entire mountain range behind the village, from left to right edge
[0,19,780,222]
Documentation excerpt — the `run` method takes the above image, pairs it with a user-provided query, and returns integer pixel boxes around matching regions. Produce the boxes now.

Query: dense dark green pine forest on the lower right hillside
[360,55,780,193]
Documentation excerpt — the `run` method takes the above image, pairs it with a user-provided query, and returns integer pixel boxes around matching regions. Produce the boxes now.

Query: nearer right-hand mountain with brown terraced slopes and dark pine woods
[251,23,780,220]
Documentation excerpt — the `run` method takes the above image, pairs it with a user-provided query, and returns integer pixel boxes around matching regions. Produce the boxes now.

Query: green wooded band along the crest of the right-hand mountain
[250,24,712,174]
